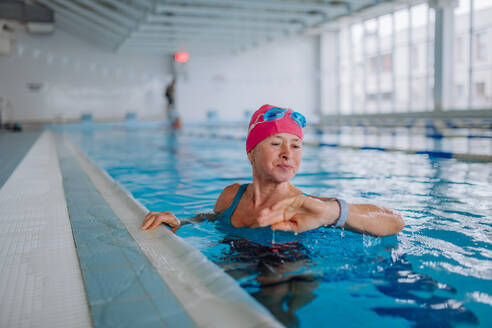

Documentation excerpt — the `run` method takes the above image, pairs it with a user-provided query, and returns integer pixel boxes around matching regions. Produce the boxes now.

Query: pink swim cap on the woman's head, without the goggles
[246,105,302,153]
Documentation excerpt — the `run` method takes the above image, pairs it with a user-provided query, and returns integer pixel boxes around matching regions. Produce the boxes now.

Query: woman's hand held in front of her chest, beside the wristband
[257,195,340,232]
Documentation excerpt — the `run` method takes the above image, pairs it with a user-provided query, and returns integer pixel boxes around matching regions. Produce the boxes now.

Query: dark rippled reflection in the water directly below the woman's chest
[215,238,320,327]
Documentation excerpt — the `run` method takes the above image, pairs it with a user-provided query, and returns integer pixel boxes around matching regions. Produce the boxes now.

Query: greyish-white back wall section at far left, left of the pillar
[0,29,171,122]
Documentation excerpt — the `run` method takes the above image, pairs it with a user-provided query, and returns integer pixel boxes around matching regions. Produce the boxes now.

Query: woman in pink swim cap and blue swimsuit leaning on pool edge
[141,105,404,236]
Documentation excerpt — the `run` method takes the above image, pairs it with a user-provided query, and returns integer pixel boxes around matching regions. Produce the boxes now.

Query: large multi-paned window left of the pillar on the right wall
[337,3,434,113]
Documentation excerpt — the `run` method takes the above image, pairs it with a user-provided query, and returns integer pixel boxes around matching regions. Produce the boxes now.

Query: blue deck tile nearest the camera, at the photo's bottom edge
[91,299,163,328]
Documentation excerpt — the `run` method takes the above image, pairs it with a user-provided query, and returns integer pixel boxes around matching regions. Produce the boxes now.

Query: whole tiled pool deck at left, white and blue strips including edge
[0,132,280,327]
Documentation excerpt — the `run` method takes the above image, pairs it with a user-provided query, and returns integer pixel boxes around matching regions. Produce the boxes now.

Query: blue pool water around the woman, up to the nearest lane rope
[59,123,492,327]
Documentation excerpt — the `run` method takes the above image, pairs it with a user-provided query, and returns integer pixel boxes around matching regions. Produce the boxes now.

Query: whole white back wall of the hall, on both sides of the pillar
[0,29,319,122]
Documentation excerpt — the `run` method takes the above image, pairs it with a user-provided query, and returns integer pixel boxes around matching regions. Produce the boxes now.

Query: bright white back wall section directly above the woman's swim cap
[177,36,319,121]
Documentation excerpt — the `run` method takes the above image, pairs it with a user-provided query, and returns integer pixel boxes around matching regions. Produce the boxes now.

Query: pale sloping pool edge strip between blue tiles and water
[57,134,282,327]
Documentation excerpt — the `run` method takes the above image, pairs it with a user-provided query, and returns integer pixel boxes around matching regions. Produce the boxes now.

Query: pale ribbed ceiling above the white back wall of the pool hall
[35,0,388,55]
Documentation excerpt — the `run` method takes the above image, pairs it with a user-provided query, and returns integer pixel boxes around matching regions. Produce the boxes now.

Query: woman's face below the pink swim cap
[248,133,302,182]
